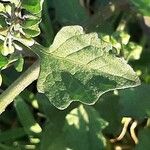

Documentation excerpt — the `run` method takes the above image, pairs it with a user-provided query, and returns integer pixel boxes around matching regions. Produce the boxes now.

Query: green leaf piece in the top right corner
[130,0,150,16]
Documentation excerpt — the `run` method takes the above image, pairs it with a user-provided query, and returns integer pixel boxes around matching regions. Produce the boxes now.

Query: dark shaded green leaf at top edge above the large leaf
[53,0,88,25]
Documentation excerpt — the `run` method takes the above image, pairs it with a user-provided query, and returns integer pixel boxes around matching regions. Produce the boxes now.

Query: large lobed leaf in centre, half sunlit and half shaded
[32,26,140,109]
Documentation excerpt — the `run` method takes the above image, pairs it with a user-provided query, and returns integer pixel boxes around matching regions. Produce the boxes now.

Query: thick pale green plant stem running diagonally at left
[0,61,40,114]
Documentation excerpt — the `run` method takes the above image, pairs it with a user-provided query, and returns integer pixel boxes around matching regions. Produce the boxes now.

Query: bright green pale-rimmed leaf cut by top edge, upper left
[21,0,44,14]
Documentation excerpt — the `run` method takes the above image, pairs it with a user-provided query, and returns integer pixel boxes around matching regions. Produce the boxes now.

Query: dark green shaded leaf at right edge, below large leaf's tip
[119,84,150,119]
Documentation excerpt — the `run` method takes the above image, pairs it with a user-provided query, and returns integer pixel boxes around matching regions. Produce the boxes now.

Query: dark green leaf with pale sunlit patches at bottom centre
[64,105,108,150]
